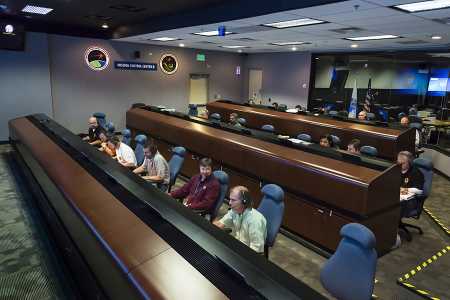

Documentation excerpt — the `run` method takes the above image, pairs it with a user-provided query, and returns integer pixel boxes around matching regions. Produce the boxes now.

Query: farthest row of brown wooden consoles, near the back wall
[206,101,415,161]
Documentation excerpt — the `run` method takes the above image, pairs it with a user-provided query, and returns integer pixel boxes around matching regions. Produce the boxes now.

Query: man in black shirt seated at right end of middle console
[397,151,425,200]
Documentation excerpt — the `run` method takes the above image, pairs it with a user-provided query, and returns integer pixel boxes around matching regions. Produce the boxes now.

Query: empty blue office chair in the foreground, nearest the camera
[320,223,377,300]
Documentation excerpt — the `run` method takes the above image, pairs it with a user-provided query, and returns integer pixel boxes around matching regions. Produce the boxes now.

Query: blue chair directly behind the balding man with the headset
[257,184,284,258]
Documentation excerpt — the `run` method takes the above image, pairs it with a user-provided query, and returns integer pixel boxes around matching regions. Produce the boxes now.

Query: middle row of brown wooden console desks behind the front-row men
[127,107,400,254]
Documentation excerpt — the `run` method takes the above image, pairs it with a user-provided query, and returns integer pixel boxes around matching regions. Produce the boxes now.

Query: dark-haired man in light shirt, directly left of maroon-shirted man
[133,139,170,192]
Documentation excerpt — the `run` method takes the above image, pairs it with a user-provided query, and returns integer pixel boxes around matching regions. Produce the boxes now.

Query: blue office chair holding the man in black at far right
[399,158,433,242]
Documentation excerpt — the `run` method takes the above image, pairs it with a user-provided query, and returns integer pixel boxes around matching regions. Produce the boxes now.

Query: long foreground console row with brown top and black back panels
[9,115,323,299]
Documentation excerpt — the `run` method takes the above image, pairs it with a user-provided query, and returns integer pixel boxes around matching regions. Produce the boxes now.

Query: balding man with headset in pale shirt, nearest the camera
[214,186,267,253]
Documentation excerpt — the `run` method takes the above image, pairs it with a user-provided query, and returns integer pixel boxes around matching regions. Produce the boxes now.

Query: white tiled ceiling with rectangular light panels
[114,0,450,53]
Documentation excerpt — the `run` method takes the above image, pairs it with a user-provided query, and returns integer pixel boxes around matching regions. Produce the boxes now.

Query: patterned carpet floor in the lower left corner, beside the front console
[0,145,66,300]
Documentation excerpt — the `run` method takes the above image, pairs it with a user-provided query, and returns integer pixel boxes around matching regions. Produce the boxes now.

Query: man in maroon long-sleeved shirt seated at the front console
[170,157,220,212]
